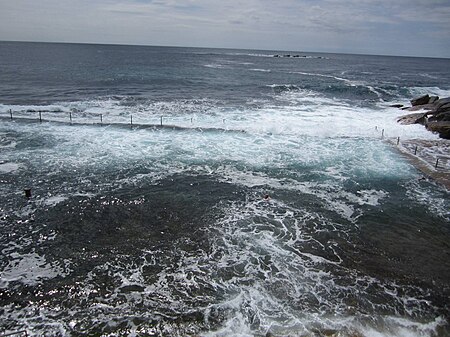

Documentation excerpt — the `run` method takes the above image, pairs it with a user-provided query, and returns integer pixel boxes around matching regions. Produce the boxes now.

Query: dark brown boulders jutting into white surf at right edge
[398,95,450,139]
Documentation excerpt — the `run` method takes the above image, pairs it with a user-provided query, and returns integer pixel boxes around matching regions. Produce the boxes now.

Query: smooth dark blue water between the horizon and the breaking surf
[0,42,450,104]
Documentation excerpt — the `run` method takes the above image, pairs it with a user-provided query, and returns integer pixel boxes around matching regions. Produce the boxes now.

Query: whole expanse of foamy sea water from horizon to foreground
[0,42,450,337]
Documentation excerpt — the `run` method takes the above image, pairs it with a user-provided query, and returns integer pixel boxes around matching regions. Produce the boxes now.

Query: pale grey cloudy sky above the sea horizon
[0,0,450,58]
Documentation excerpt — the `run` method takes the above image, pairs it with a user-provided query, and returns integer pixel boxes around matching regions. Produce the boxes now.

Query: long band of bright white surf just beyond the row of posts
[2,91,438,139]
